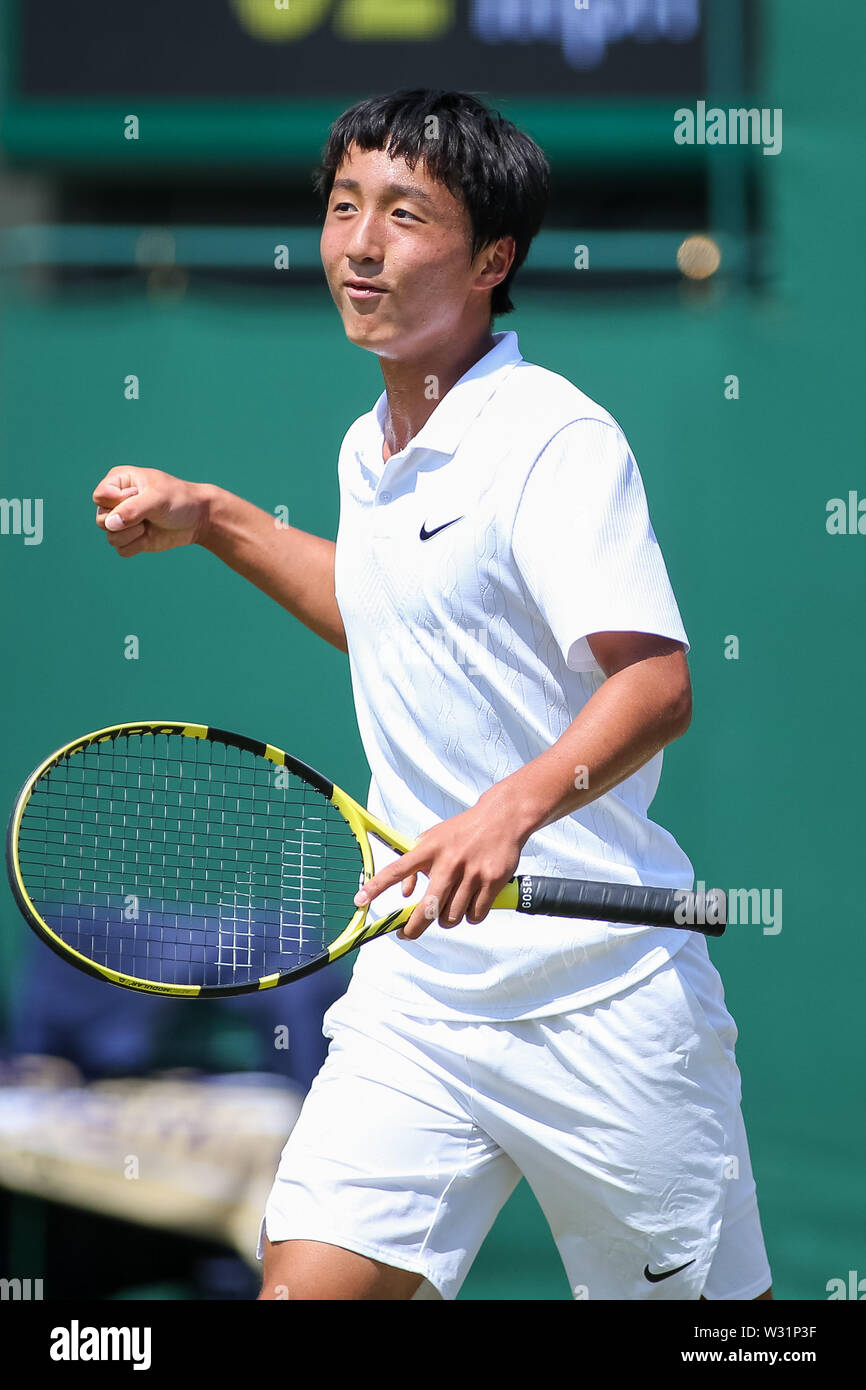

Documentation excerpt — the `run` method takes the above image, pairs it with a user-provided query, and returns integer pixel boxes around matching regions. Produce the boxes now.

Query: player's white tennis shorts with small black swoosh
[259,934,771,1300]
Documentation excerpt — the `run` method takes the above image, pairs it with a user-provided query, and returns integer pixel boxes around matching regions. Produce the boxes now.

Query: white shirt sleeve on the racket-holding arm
[512,418,689,671]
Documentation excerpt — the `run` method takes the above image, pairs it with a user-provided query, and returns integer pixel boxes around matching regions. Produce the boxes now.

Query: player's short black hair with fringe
[313,88,550,318]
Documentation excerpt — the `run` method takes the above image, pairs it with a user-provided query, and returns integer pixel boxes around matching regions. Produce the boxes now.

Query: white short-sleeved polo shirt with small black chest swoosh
[335,331,694,1020]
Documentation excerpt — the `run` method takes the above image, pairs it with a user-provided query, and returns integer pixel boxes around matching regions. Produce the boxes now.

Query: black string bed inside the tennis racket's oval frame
[18,734,363,987]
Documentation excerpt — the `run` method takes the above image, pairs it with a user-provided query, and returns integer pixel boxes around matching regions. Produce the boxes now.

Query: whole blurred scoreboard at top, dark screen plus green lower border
[0,0,741,167]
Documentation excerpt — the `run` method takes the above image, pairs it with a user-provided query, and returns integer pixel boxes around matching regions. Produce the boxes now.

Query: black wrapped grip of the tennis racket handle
[517,874,727,937]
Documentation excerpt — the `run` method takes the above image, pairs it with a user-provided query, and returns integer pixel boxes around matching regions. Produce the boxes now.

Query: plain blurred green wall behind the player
[0,0,866,1300]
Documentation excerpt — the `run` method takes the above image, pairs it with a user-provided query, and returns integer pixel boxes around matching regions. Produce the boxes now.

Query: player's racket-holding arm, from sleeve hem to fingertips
[356,632,692,940]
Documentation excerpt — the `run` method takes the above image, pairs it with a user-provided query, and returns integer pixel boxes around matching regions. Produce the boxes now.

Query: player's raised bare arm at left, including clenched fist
[93,468,346,652]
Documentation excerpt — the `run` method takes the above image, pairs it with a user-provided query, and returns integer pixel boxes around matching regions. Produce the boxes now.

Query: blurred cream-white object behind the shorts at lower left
[0,1058,303,1268]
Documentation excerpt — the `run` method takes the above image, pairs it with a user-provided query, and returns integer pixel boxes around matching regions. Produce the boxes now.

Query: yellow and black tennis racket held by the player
[7,720,727,998]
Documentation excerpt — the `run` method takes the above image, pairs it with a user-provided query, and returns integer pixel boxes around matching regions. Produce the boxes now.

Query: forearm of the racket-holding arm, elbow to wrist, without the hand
[482,656,691,841]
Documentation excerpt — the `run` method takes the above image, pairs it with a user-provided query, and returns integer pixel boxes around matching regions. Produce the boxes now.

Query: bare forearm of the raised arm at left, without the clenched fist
[197,484,346,652]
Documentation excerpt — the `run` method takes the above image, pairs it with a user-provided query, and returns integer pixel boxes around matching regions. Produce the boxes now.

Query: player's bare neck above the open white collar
[379,325,495,460]
